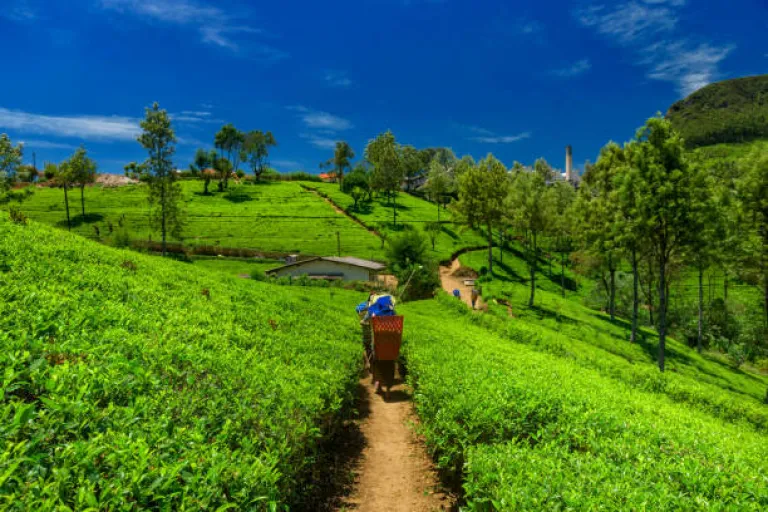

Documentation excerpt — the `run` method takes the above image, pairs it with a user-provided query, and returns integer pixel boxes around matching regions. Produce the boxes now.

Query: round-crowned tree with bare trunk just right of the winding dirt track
[453,153,509,274]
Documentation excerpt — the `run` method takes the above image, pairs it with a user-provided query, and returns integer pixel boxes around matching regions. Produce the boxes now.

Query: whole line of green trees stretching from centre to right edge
[339,118,768,371]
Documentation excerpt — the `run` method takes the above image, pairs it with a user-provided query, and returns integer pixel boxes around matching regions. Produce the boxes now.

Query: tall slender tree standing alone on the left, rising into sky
[138,102,181,256]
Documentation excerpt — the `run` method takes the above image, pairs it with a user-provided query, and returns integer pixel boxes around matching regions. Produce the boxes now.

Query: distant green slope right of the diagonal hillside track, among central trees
[305,183,488,260]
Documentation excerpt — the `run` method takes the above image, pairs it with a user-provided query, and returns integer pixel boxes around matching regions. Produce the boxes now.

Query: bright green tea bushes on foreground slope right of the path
[401,292,768,510]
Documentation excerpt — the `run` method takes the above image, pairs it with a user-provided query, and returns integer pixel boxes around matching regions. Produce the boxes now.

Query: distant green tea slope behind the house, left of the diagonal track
[10,181,380,258]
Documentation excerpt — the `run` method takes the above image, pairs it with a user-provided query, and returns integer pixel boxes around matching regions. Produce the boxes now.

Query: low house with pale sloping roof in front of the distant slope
[266,256,386,281]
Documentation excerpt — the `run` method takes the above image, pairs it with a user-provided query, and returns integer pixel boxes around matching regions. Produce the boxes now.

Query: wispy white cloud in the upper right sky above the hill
[573,0,735,95]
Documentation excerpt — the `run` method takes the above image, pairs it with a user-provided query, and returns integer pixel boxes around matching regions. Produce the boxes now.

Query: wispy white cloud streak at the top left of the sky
[101,0,288,60]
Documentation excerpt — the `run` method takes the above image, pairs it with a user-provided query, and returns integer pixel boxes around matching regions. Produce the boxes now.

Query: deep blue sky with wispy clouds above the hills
[0,0,768,172]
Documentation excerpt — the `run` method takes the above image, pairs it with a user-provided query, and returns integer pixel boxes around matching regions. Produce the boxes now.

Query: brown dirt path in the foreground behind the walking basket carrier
[339,378,454,512]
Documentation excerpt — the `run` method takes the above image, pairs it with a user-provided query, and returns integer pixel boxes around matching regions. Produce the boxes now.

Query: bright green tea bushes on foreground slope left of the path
[0,218,360,510]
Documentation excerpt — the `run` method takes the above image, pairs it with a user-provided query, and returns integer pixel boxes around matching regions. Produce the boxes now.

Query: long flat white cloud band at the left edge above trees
[0,107,140,141]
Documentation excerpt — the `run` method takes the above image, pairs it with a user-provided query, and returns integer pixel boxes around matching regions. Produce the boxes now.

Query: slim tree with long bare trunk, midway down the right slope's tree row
[506,166,551,307]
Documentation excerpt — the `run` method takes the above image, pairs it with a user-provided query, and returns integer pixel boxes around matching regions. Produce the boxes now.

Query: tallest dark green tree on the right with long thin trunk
[633,117,695,372]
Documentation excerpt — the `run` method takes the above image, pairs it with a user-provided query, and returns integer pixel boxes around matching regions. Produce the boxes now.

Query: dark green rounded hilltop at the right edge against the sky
[667,75,768,148]
